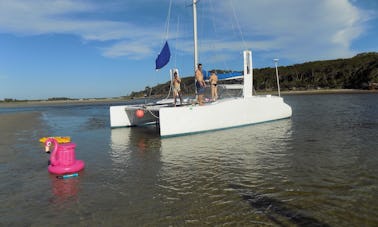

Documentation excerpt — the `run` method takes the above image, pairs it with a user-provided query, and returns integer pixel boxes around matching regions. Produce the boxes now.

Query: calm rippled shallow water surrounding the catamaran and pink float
[0,94,378,226]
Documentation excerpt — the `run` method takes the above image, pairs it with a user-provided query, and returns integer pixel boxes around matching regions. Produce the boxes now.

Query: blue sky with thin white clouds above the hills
[0,0,378,99]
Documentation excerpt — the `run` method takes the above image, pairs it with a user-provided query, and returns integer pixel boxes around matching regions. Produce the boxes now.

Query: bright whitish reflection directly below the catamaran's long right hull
[161,120,292,176]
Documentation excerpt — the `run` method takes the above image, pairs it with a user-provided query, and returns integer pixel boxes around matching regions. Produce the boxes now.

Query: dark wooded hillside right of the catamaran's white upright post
[266,52,378,90]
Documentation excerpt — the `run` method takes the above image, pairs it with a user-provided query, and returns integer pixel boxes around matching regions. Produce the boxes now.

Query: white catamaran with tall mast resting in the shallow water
[110,0,292,137]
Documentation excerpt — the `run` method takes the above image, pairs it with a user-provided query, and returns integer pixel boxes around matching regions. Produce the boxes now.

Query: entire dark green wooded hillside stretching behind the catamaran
[129,52,378,97]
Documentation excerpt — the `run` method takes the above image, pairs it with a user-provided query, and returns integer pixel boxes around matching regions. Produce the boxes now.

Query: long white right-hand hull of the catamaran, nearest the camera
[159,96,292,137]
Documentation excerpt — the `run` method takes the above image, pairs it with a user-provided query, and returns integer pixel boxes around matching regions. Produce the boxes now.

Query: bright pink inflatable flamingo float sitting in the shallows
[45,138,84,174]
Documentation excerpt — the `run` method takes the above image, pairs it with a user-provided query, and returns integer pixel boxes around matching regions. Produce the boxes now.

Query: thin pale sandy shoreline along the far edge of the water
[0,89,378,108]
